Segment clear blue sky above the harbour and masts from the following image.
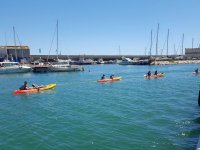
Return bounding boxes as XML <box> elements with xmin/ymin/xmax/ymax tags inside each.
<box><xmin>0</xmin><ymin>0</ymin><xmax>200</xmax><ymax>55</ymax></box>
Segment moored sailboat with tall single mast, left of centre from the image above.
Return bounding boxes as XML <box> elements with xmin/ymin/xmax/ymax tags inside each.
<box><xmin>49</xmin><ymin>20</ymin><xmax>84</xmax><ymax>72</ymax></box>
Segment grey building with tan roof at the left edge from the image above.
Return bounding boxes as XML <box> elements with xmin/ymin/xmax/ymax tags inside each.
<box><xmin>0</xmin><ymin>46</ymin><xmax>30</xmax><ymax>62</ymax></box>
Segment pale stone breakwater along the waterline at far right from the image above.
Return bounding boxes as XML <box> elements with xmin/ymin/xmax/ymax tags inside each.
<box><xmin>151</xmin><ymin>60</ymin><xmax>200</xmax><ymax>65</ymax></box>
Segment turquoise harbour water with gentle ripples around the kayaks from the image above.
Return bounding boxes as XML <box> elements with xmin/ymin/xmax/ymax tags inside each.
<box><xmin>0</xmin><ymin>64</ymin><xmax>200</xmax><ymax>150</ymax></box>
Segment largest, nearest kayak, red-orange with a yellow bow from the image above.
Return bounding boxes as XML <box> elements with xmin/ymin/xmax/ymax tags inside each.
<box><xmin>13</xmin><ymin>84</ymin><xmax>56</xmax><ymax>94</ymax></box>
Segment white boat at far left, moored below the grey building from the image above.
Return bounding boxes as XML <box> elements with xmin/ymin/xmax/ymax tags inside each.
<box><xmin>0</xmin><ymin>61</ymin><xmax>31</xmax><ymax>74</ymax></box>
